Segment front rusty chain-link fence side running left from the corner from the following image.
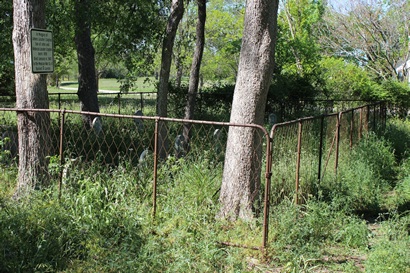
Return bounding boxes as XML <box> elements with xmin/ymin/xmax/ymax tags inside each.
<box><xmin>0</xmin><ymin>108</ymin><xmax>270</xmax><ymax>248</ymax></box>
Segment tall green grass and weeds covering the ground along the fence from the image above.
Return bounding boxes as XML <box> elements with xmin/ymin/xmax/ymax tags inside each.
<box><xmin>0</xmin><ymin>116</ymin><xmax>410</xmax><ymax>272</ymax></box>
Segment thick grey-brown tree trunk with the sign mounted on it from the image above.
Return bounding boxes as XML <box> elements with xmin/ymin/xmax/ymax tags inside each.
<box><xmin>13</xmin><ymin>0</ymin><xmax>50</xmax><ymax>198</ymax></box>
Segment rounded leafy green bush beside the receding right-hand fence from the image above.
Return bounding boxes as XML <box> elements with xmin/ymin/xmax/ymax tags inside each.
<box><xmin>321</xmin><ymin>134</ymin><xmax>396</xmax><ymax>210</ymax></box>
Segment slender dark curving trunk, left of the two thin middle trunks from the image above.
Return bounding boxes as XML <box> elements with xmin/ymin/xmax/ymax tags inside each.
<box><xmin>157</xmin><ymin>0</ymin><xmax>184</xmax><ymax>159</ymax></box>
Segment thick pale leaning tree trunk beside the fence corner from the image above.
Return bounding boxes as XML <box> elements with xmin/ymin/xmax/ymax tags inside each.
<box><xmin>219</xmin><ymin>0</ymin><xmax>279</xmax><ymax>220</ymax></box>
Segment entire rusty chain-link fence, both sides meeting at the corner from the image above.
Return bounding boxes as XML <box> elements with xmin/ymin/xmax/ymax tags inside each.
<box><xmin>0</xmin><ymin>103</ymin><xmax>386</xmax><ymax>252</ymax></box>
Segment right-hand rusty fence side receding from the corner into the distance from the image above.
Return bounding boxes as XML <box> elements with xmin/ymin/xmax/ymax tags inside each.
<box><xmin>270</xmin><ymin>102</ymin><xmax>386</xmax><ymax>204</ymax></box>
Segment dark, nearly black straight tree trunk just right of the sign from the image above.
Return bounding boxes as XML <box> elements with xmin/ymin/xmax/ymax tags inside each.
<box><xmin>74</xmin><ymin>0</ymin><xmax>100</xmax><ymax>128</ymax></box>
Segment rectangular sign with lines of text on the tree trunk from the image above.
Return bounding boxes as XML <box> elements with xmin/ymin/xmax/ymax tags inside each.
<box><xmin>31</xmin><ymin>28</ymin><xmax>54</xmax><ymax>74</ymax></box>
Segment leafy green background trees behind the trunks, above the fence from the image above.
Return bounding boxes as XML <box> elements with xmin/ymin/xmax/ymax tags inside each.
<box><xmin>0</xmin><ymin>0</ymin><xmax>409</xmax><ymax>100</ymax></box>
